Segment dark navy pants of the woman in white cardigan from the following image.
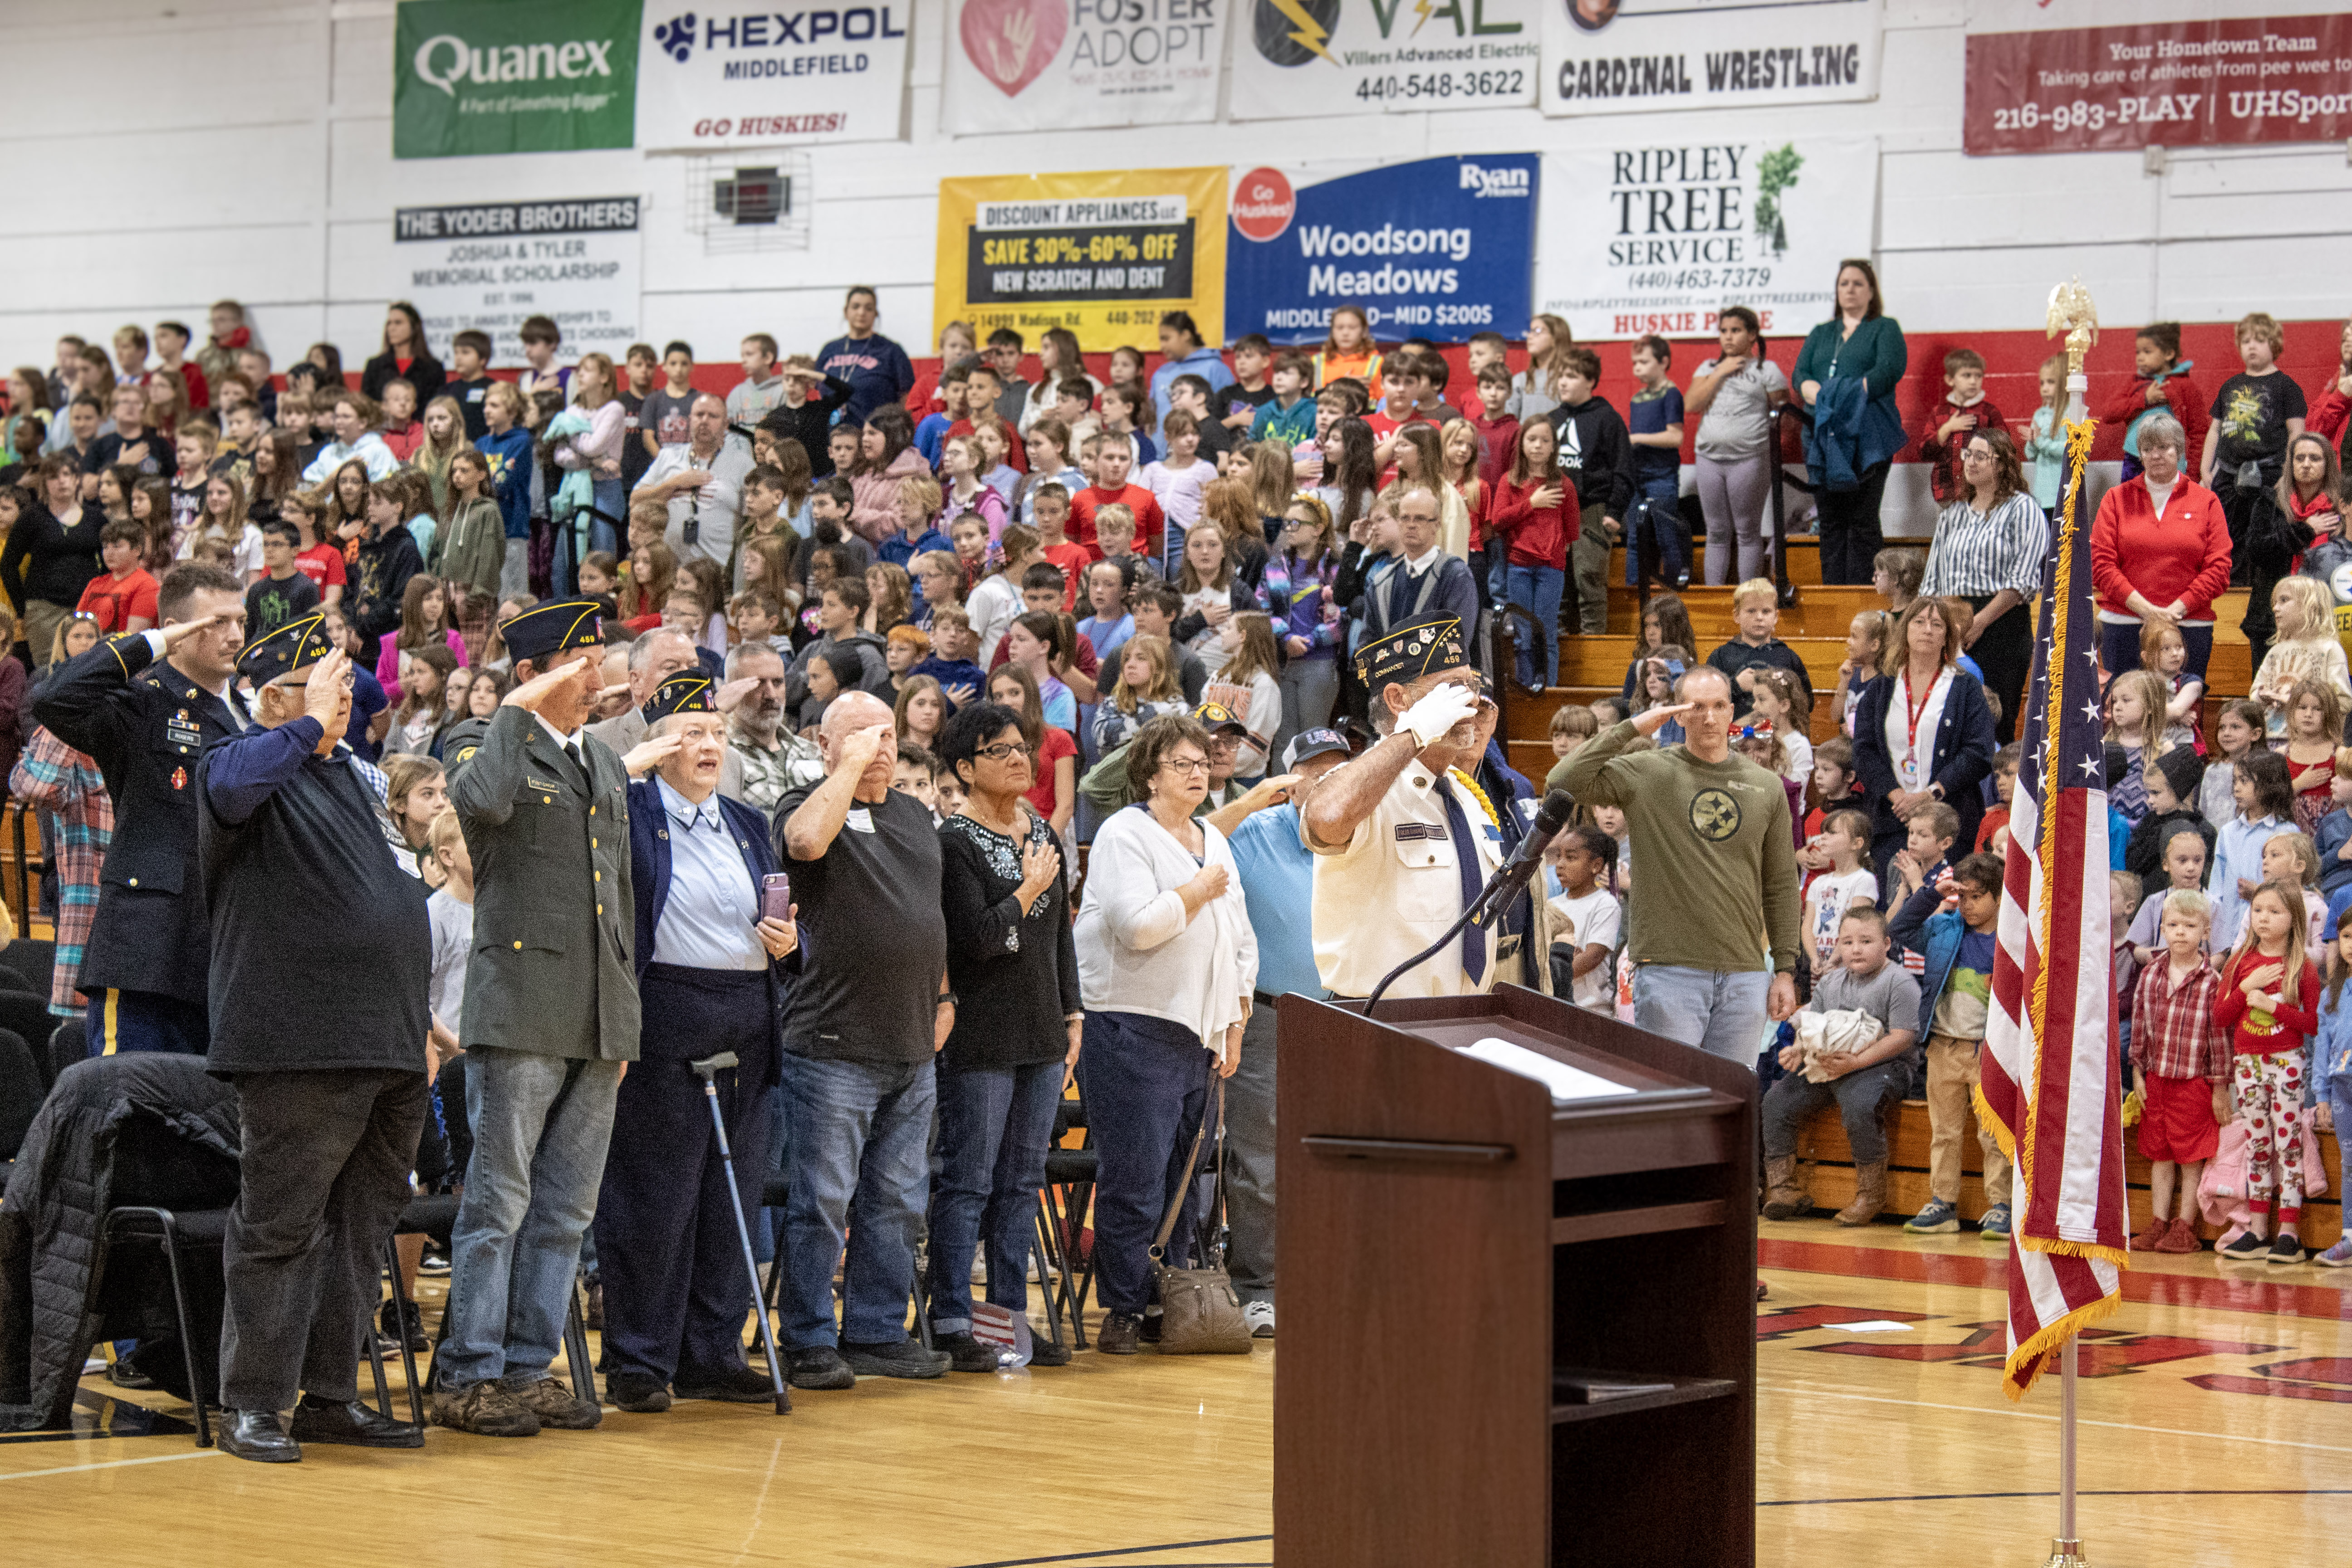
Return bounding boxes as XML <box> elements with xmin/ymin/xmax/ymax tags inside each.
<box><xmin>1077</xmin><ymin>1013</ymin><xmax>1216</xmax><ymax>1316</ymax></box>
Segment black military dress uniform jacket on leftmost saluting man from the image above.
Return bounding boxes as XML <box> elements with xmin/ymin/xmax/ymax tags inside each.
<box><xmin>33</xmin><ymin>632</ymin><xmax>252</xmax><ymax>1006</ymax></box>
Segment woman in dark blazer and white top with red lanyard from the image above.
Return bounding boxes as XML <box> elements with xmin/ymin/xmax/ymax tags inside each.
<box><xmin>1853</xmin><ymin>595</ymin><xmax>1994</xmax><ymax>886</ymax></box>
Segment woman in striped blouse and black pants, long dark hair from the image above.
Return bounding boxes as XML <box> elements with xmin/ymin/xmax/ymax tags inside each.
<box><xmin>1919</xmin><ymin>430</ymin><xmax>2048</xmax><ymax>745</ymax></box>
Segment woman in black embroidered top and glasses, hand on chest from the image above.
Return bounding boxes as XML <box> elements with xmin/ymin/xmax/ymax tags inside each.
<box><xmin>931</xmin><ymin>703</ymin><xmax>1084</xmax><ymax>1373</ymax></box>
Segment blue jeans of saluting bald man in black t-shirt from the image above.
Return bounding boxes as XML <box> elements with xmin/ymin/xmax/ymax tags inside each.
<box><xmin>781</xmin><ymin>1055</ymin><xmax>938</xmax><ymax>1349</ymax></box>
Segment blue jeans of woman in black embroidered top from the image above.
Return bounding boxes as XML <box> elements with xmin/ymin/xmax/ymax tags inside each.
<box><xmin>931</xmin><ymin>1060</ymin><xmax>1063</xmax><ymax>1333</ymax></box>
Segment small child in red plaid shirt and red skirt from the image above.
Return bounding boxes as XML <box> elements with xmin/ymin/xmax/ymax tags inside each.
<box><xmin>2131</xmin><ymin>889</ymin><xmax>2230</xmax><ymax>1253</ymax></box>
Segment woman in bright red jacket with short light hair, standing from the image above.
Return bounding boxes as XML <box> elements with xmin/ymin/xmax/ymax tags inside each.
<box><xmin>2091</xmin><ymin>414</ymin><xmax>2230</xmax><ymax>679</ymax></box>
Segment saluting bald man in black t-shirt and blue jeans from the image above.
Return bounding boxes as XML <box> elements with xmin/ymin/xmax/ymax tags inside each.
<box><xmin>776</xmin><ymin>691</ymin><xmax>955</xmax><ymax>1389</ymax></box>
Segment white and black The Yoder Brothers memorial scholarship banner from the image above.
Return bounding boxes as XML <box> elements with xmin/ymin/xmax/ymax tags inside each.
<box><xmin>393</xmin><ymin>195</ymin><xmax>644</xmax><ymax>364</ymax></box>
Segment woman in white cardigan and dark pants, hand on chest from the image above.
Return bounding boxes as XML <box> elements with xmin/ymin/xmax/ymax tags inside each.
<box><xmin>1075</xmin><ymin>715</ymin><xmax>1258</xmax><ymax>1357</ymax></box>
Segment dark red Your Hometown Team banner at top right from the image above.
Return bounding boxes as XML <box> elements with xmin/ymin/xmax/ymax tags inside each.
<box><xmin>1961</xmin><ymin>14</ymin><xmax>2352</xmax><ymax>155</ymax></box>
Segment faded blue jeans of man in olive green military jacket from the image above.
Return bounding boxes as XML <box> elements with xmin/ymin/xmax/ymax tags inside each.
<box><xmin>437</xmin><ymin>1046</ymin><xmax>621</xmax><ymax>1387</ymax></box>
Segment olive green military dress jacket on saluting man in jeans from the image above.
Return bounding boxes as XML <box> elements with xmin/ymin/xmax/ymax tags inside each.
<box><xmin>449</xmin><ymin>705</ymin><xmax>637</xmax><ymax>1063</ymax></box>
